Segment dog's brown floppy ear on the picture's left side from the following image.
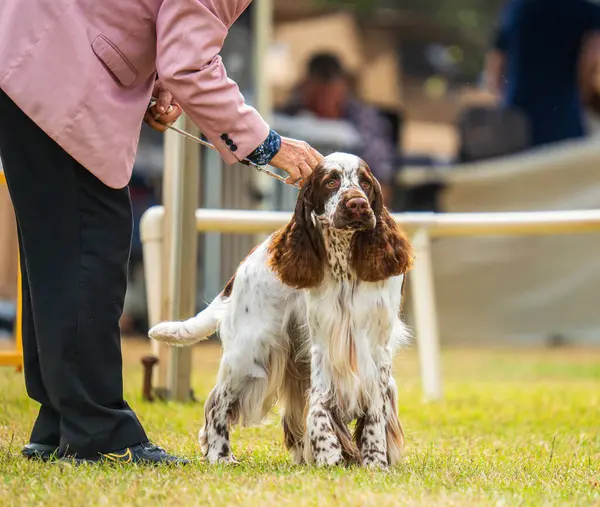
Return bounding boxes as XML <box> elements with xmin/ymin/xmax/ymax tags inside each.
<box><xmin>269</xmin><ymin>181</ymin><xmax>327</xmax><ymax>289</ymax></box>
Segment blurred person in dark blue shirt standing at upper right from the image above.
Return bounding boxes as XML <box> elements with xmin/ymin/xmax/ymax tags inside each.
<box><xmin>485</xmin><ymin>0</ymin><xmax>600</xmax><ymax>146</ymax></box>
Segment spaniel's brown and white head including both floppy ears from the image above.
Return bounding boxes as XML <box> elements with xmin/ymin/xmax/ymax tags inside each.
<box><xmin>269</xmin><ymin>153</ymin><xmax>412</xmax><ymax>288</ymax></box>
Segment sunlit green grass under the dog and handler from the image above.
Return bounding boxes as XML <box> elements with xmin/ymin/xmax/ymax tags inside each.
<box><xmin>0</xmin><ymin>342</ymin><xmax>600</xmax><ymax>507</ymax></box>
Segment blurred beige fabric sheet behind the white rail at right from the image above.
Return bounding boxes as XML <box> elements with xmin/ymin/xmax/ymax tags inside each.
<box><xmin>404</xmin><ymin>142</ymin><xmax>600</xmax><ymax>344</ymax></box>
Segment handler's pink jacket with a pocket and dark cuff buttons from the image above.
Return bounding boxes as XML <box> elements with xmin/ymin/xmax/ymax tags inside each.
<box><xmin>0</xmin><ymin>0</ymin><xmax>269</xmax><ymax>188</ymax></box>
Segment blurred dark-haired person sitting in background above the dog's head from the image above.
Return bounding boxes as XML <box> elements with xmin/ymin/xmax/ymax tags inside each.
<box><xmin>281</xmin><ymin>53</ymin><xmax>395</xmax><ymax>206</ymax></box>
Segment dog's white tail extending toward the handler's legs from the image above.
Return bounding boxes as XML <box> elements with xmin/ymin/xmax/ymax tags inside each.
<box><xmin>148</xmin><ymin>294</ymin><xmax>229</xmax><ymax>347</ymax></box>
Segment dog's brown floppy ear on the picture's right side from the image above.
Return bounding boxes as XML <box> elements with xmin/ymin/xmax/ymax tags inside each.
<box><xmin>352</xmin><ymin>179</ymin><xmax>413</xmax><ymax>282</ymax></box>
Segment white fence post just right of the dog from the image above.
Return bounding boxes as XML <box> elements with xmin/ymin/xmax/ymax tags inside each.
<box><xmin>409</xmin><ymin>228</ymin><xmax>442</xmax><ymax>400</ymax></box>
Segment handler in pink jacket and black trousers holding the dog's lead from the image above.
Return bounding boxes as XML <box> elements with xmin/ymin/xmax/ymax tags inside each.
<box><xmin>0</xmin><ymin>0</ymin><xmax>321</xmax><ymax>463</ymax></box>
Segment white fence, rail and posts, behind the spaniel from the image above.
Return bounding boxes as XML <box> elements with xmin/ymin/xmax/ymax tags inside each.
<box><xmin>141</xmin><ymin>206</ymin><xmax>600</xmax><ymax>399</ymax></box>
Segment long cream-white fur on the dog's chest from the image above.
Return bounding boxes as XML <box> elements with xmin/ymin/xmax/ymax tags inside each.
<box><xmin>306</xmin><ymin>272</ymin><xmax>406</xmax><ymax>419</ymax></box>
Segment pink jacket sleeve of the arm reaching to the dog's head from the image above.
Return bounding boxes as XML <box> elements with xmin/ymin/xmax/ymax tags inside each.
<box><xmin>156</xmin><ymin>0</ymin><xmax>269</xmax><ymax>164</ymax></box>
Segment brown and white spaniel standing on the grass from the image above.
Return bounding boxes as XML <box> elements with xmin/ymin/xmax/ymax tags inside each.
<box><xmin>149</xmin><ymin>153</ymin><xmax>412</xmax><ymax>467</ymax></box>
